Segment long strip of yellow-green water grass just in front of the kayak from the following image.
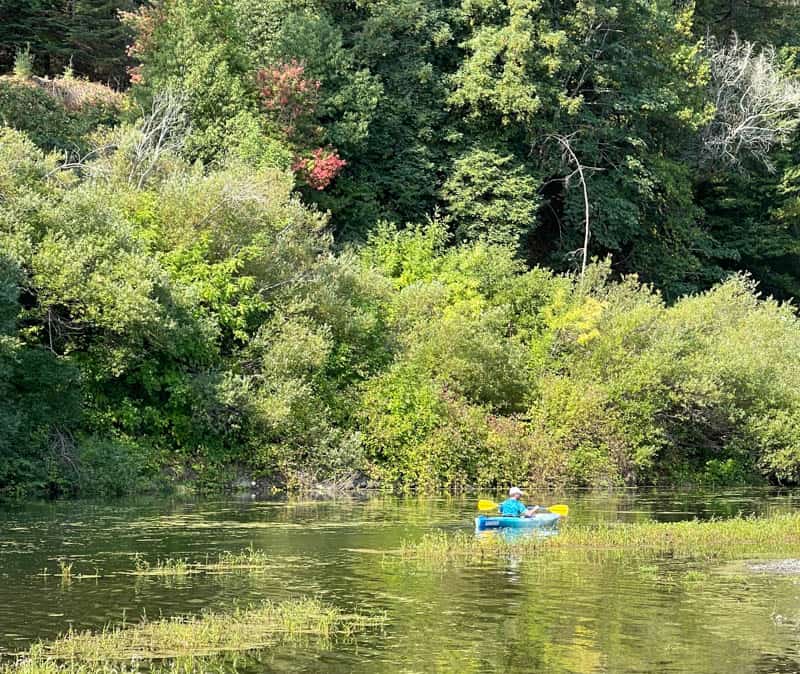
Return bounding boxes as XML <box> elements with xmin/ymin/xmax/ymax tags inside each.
<box><xmin>396</xmin><ymin>513</ymin><xmax>800</xmax><ymax>564</ymax></box>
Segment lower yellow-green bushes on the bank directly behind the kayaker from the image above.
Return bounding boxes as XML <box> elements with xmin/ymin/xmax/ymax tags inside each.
<box><xmin>360</xmin><ymin>227</ymin><xmax>800</xmax><ymax>487</ymax></box>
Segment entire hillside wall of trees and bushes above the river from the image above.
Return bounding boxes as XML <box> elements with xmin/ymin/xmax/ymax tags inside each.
<box><xmin>0</xmin><ymin>0</ymin><xmax>800</xmax><ymax>494</ymax></box>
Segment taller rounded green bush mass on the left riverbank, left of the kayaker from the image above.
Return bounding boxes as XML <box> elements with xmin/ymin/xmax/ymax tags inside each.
<box><xmin>0</xmin><ymin>119</ymin><xmax>390</xmax><ymax>493</ymax></box>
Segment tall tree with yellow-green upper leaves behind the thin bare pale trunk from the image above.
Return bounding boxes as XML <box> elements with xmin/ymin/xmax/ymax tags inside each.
<box><xmin>450</xmin><ymin>0</ymin><xmax>708</xmax><ymax>294</ymax></box>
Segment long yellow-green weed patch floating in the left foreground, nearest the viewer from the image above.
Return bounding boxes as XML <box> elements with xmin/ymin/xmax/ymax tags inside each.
<box><xmin>22</xmin><ymin>599</ymin><xmax>385</xmax><ymax>660</ymax></box>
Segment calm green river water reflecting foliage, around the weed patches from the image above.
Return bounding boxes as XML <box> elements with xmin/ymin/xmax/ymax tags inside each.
<box><xmin>0</xmin><ymin>491</ymin><xmax>800</xmax><ymax>674</ymax></box>
